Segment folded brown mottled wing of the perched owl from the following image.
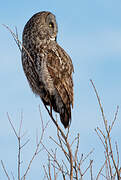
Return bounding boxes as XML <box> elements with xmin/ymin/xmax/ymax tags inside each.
<box><xmin>47</xmin><ymin>44</ymin><xmax>74</xmax><ymax>109</ymax></box>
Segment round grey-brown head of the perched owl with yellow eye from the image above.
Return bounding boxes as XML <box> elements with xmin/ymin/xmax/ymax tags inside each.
<box><xmin>24</xmin><ymin>11</ymin><xmax>58</xmax><ymax>41</ymax></box>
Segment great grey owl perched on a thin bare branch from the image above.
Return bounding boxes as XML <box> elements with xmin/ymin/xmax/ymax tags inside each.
<box><xmin>22</xmin><ymin>11</ymin><xmax>74</xmax><ymax>128</ymax></box>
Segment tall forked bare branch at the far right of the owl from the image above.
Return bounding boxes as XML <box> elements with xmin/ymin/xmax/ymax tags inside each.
<box><xmin>90</xmin><ymin>80</ymin><xmax>120</xmax><ymax>180</ymax></box>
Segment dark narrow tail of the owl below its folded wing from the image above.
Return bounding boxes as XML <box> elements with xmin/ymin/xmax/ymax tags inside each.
<box><xmin>60</xmin><ymin>108</ymin><xmax>71</xmax><ymax>128</ymax></box>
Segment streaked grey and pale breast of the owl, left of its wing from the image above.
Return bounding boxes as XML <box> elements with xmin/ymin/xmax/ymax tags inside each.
<box><xmin>22</xmin><ymin>46</ymin><xmax>55</xmax><ymax>100</ymax></box>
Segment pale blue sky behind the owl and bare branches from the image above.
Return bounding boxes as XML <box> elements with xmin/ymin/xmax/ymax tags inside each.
<box><xmin>0</xmin><ymin>0</ymin><xmax>121</xmax><ymax>179</ymax></box>
